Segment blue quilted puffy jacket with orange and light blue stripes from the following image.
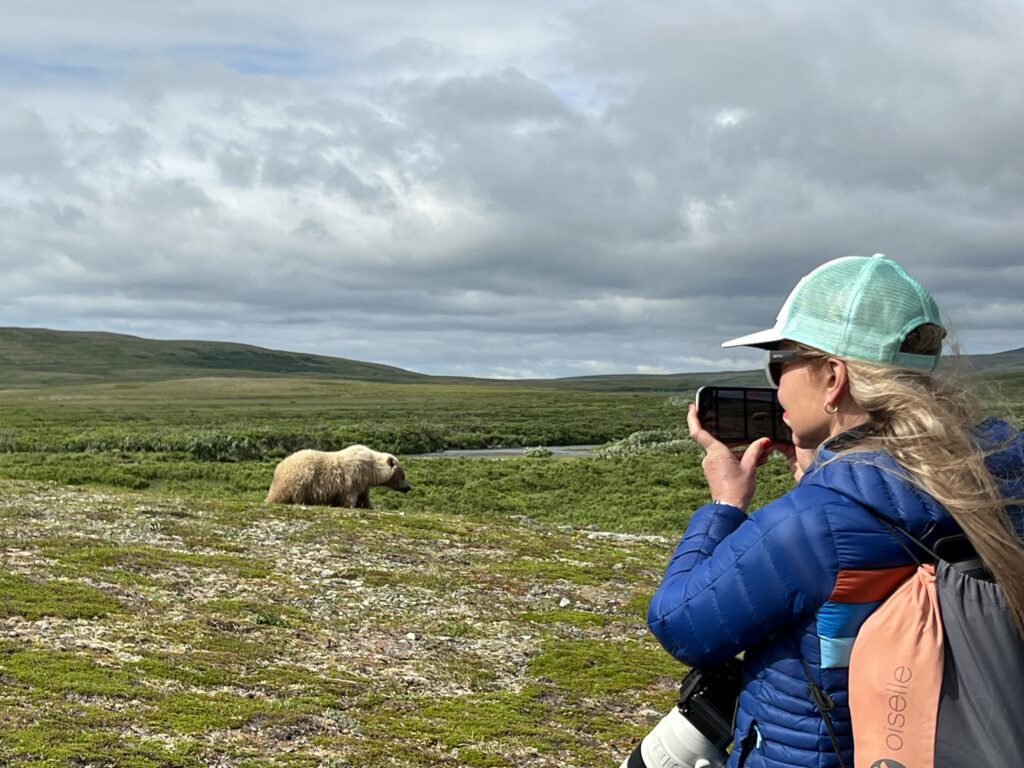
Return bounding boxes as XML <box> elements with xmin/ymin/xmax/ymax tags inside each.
<box><xmin>647</xmin><ymin>421</ymin><xmax>1024</xmax><ymax>768</ymax></box>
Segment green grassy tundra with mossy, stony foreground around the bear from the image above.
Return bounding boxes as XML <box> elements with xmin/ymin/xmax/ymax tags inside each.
<box><xmin>0</xmin><ymin>331</ymin><xmax>1019</xmax><ymax>768</ymax></box>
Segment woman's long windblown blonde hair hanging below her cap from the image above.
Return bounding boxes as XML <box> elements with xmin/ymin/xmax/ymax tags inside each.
<box><xmin>808</xmin><ymin>326</ymin><xmax>1024</xmax><ymax>637</ymax></box>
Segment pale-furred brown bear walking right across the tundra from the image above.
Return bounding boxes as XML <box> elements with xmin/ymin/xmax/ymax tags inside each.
<box><xmin>266</xmin><ymin>445</ymin><xmax>413</xmax><ymax>509</ymax></box>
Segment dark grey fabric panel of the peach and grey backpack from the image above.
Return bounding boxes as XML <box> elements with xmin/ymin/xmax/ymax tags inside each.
<box><xmin>935</xmin><ymin>560</ymin><xmax>1024</xmax><ymax>768</ymax></box>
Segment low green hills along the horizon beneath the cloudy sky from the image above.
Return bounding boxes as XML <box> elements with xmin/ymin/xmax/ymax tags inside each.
<box><xmin>0</xmin><ymin>328</ymin><xmax>1024</xmax><ymax>392</ymax></box>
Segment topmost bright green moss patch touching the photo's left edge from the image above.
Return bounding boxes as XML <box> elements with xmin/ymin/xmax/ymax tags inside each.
<box><xmin>0</xmin><ymin>573</ymin><xmax>124</xmax><ymax>622</ymax></box>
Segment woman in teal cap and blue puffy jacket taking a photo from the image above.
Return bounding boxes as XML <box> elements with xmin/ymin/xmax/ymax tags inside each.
<box><xmin>647</xmin><ymin>255</ymin><xmax>1024</xmax><ymax>768</ymax></box>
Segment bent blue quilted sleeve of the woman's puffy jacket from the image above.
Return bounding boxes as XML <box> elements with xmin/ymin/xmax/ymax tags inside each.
<box><xmin>647</xmin><ymin>488</ymin><xmax>839</xmax><ymax>667</ymax></box>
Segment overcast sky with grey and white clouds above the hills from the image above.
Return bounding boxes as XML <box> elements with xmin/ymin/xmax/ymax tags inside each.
<box><xmin>0</xmin><ymin>0</ymin><xmax>1024</xmax><ymax>377</ymax></box>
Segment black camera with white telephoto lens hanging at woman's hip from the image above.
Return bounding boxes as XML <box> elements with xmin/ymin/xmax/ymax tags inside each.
<box><xmin>620</xmin><ymin>658</ymin><xmax>742</xmax><ymax>768</ymax></box>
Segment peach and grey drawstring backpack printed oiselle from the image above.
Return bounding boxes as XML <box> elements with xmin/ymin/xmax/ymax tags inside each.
<box><xmin>849</xmin><ymin>522</ymin><xmax>1024</xmax><ymax>768</ymax></box>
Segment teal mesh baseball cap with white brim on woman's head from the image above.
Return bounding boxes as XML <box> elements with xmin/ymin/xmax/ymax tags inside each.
<box><xmin>722</xmin><ymin>253</ymin><xmax>945</xmax><ymax>371</ymax></box>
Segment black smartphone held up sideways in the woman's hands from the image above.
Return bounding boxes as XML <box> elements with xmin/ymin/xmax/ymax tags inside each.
<box><xmin>697</xmin><ymin>387</ymin><xmax>793</xmax><ymax>442</ymax></box>
